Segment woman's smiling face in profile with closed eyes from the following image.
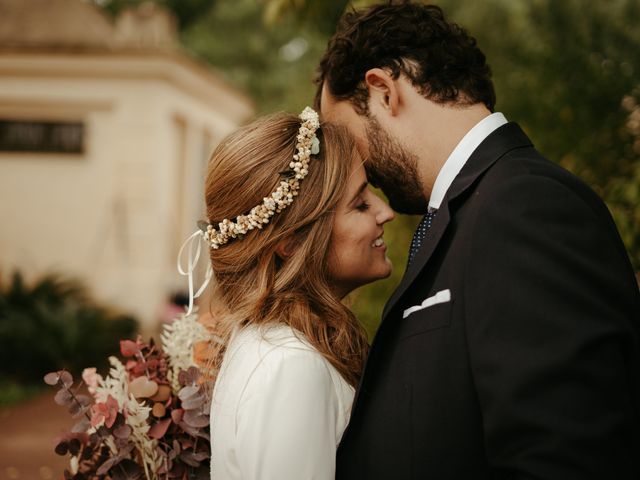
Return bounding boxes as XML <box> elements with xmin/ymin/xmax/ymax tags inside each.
<box><xmin>329</xmin><ymin>159</ymin><xmax>394</xmax><ymax>296</ymax></box>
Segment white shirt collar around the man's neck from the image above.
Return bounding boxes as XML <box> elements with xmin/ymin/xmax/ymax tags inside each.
<box><xmin>429</xmin><ymin>112</ymin><xmax>507</xmax><ymax>212</ymax></box>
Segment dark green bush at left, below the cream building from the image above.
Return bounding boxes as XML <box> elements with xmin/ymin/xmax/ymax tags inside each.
<box><xmin>0</xmin><ymin>272</ymin><xmax>136</xmax><ymax>382</ymax></box>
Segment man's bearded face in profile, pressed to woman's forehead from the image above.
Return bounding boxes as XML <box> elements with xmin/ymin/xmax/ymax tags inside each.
<box><xmin>320</xmin><ymin>88</ymin><xmax>427</xmax><ymax>214</ymax></box>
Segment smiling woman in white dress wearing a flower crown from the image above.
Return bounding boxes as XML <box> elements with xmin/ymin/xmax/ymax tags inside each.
<box><xmin>190</xmin><ymin>108</ymin><xmax>393</xmax><ymax>480</ymax></box>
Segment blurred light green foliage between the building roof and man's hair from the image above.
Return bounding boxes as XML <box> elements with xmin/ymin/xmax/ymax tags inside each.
<box><xmin>181</xmin><ymin>0</ymin><xmax>326</xmax><ymax>113</ymax></box>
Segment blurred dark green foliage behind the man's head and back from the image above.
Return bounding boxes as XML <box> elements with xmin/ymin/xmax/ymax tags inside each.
<box><xmin>443</xmin><ymin>0</ymin><xmax>640</xmax><ymax>271</ymax></box>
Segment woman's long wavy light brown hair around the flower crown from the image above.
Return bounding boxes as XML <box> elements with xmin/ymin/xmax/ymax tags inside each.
<box><xmin>200</xmin><ymin>114</ymin><xmax>368</xmax><ymax>386</ymax></box>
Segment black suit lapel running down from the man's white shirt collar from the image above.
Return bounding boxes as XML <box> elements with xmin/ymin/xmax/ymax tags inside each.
<box><xmin>382</xmin><ymin>123</ymin><xmax>532</xmax><ymax>321</ymax></box>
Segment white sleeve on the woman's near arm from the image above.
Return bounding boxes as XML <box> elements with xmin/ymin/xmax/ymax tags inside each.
<box><xmin>236</xmin><ymin>348</ymin><xmax>338</xmax><ymax>480</ymax></box>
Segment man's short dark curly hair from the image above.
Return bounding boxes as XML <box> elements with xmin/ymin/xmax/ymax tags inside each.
<box><xmin>316</xmin><ymin>1</ymin><xmax>496</xmax><ymax>115</ymax></box>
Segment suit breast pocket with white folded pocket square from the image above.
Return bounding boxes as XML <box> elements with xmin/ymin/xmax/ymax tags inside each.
<box><xmin>400</xmin><ymin>290</ymin><xmax>454</xmax><ymax>339</ymax></box>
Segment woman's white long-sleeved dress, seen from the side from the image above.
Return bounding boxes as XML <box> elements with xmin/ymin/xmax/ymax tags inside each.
<box><xmin>211</xmin><ymin>325</ymin><xmax>354</xmax><ymax>480</ymax></box>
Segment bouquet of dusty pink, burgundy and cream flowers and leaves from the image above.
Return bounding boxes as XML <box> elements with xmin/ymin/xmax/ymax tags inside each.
<box><xmin>44</xmin><ymin>313</ymin><xmax>211</xmax><ymax>480</ymax></box>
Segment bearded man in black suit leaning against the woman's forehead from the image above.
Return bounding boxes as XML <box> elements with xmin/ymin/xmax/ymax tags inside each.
<box><xmin>317</xmin><ymin>3</ymin><xmax>640</xmax><ymax>480</ymax></box>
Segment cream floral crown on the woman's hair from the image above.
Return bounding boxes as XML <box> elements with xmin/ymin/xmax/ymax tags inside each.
<box><xmin>198</xmin><ymin>107</ymin><xmax>320</xmax><ymax>249</ymax></box>
